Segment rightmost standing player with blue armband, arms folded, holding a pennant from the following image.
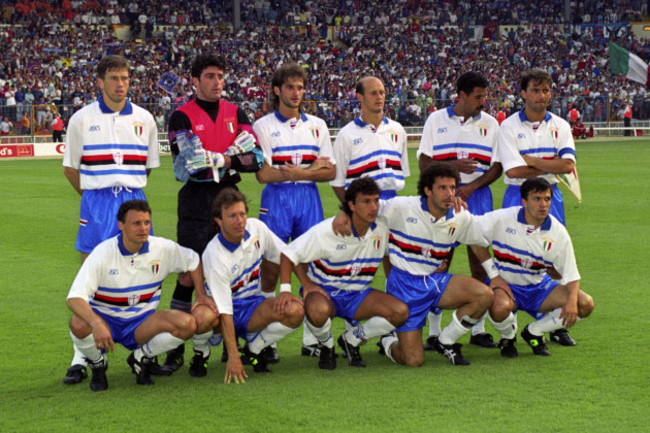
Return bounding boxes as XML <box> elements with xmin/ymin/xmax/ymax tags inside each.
<box><xmin>498</xmin><ymin>70</ymin><xmax>576</xmax><ymax>346</ymax></box>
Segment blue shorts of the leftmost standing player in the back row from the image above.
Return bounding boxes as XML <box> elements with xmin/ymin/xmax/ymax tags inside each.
<box><xmin>75</xmin><ymin>186</ymin><xmax>147</xmax><ymax>253</ymax></box>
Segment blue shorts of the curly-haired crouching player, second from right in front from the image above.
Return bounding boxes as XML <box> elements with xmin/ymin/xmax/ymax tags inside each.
<box><xmin>386</xmin><ymin>266</ymin><xmax>453</xmax><ymax>332</ymax></box>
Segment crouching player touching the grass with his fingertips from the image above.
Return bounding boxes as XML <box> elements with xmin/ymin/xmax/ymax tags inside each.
<box><xmin>190</xmin><ymin>188</ymin><xmax>304</xmax><ymax>383</ymax></box>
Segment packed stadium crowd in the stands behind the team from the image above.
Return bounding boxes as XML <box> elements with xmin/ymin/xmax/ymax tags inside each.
<box><xmin>0</xmin><ymin>0</ymin><xmax>650</xmax><ymax>133</ymax></box>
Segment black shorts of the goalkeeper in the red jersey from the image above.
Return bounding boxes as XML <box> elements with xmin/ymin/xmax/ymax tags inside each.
<box><xmin>176</xmin><ymin>180</ymin><xmax>237</xmax><ymax>255</ymax></box>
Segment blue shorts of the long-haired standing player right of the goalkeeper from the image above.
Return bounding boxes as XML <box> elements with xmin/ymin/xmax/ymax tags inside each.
<box><xmin>260</xmin><ymin>183</ymin><xmax>323</xmax><ymax>243</ymax></box>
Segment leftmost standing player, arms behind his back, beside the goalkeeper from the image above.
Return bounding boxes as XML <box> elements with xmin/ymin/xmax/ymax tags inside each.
<box><xmin>63</xmin><ymin>55</ymin><xmax>160</xmax><ymax>385</ymax></box>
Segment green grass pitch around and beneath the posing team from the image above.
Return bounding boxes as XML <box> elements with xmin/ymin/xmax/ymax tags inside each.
<box><xmin>0</xmin><ymin>140</ymin><xmax>650</xmax><ymax>432</ymax></box>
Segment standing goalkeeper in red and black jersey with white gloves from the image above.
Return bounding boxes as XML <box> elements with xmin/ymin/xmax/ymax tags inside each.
<box><xmin>162</xmin><ymin>55</ymin><xmax>264</xmax><ymax>373</ymax></box>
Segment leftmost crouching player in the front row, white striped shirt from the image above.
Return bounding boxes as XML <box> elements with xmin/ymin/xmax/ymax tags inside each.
<box><xmin>67</xmin><ymin>200</ymin><xmax>203</xmax><ymax>391</ymax></box>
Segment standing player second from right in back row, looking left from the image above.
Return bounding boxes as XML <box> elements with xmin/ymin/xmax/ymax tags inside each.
<box><xmin>417</xmin><ymin>72</ymin><xmax>502</xmax><ymax>350</ymax></box>
